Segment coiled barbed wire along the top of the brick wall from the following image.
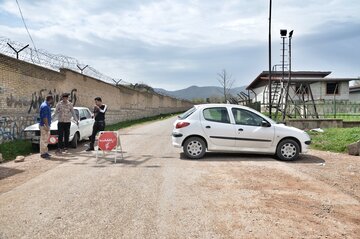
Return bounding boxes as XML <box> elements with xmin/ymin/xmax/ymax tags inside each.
<box><xmin>0</xmin><ymin>36</ymin><xmax>131</xmax><ymax>85</ymax></box>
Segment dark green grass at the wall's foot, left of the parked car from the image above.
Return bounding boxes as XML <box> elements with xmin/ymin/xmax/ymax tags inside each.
<box><xmin>0</xmin><ymin>139</ymin><xmax>33</xmax><ymax>161</ymax></box>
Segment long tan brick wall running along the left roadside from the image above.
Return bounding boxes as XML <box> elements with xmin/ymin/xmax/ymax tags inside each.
<box><xmin>0</xmin><ymin>54</ymin><xmax>192</xmax><ymax>143</ymax></box>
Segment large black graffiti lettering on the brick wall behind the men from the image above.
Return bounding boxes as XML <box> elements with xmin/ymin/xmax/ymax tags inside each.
<box><xmin>6</xmin><ymin>89</ymin><xmax>78</xmax><ymax>114</ymax></box>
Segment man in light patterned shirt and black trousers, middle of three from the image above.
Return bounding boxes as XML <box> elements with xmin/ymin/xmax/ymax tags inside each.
<box><xmin>54</xmin><ymin>93</ymin><xmax>79</xmax><ymax>154</ymax></box>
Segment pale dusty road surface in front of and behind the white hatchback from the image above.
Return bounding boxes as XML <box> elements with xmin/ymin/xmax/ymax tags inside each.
<box><xmin>0</xmin><ymin>118</ymin><xmax>360</xmax><ymax>239</ymax></box>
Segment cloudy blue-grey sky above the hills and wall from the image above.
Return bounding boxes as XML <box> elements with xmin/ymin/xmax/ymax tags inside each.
<box><xmin>0</xmin><ymin>0</ymin><xmax>360</xmax><ymax>90</ymax></box>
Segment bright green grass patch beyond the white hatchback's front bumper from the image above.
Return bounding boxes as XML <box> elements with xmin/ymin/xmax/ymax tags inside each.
<box><xmin>308</xmin><ymin>127</ymin><xmax>360</xmax><ymax>153</ymax></box>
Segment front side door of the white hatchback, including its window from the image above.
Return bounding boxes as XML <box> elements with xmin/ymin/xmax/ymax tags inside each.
<box><xmin>231</xmin><ymin>108</ymin><xmax>275</xmax><ymax>152</ymax></box>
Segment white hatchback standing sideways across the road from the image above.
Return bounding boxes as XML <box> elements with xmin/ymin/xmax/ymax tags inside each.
<box><xmin>172</xmin><ymin>104</ymin><xmax>311</xmax><ymax>161</ymax></box>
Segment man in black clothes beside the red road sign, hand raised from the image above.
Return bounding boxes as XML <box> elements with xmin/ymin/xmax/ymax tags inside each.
<box><xmin>86</xmin><ymin>97</ymin><xmax>107</xmax><ymax>151</ymax></box>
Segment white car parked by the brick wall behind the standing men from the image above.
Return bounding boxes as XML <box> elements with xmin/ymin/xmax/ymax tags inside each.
<box><xmin>24</xmin><ymin>107</ymin><xmax>94</xmax><ymax>148</ymax></box>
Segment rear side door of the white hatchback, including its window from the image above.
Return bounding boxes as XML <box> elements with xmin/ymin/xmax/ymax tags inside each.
<box><xmin>201</xmin><ymin>107</ymin><xmax>236</xmax><ymax>150</ymax></box>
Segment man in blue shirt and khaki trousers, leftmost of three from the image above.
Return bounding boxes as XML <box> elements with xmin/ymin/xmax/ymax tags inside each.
<box><xmin>39</xmin><ymin>95</ymin><xmax>54</xmax><ymax>159</ymax></box>
